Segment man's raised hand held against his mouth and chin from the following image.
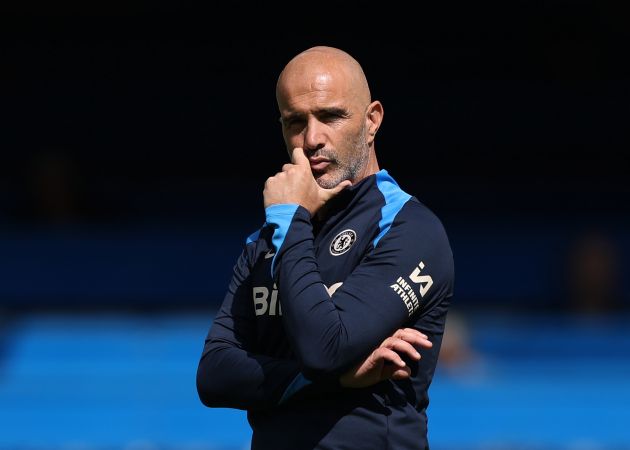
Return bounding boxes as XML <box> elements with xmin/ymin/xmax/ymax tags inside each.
<box><xmin>263</xmin><ymin>147</ymin><xmax>352</xmax><ymax>216</ymax></box>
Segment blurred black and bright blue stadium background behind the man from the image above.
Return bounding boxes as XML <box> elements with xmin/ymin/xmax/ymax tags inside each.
<box><xmin>0</xmin><ymin>1</ymin><xmax>630</xmax><ymax>450</ymax></box>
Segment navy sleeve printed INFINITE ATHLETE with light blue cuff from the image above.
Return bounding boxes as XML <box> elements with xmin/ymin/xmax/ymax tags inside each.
<box><xmin>266</xmin><ymin>202</ymin><xmax>454</xmax><ymax>379</ymax></box>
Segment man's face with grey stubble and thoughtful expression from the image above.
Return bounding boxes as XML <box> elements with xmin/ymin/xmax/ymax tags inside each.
<box><xmin>278</xmin><ymin>72</ymin><xmax>369</xmax><ymax>189</ymax></box>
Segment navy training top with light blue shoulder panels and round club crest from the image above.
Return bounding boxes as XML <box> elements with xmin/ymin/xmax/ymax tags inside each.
<box><xmin>197</xmin><ymin>170</ymin><xmax>454</xmax><ymax>450</ymax></box>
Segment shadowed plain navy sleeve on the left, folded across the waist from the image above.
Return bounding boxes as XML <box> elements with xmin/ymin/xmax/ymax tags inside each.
<box><xmin>197</xmin><ymin>246</ymin><xmax>299</xmax><ymax>410</ymax></box>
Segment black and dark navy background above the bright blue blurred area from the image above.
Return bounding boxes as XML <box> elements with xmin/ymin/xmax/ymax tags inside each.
<box><xmin>0</xmin><ymin>1</ymin><xmax>630</xmax><ymax>308</ymax></box>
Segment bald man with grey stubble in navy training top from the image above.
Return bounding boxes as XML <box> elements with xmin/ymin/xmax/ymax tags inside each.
<box><xmin>197</xmin><ymin>47</ymin><xmax>454</xmax><ymax>450</ymax></box>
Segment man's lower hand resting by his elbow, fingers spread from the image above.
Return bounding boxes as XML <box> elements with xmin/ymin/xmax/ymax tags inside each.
<box><xmin>339</xmin><ymin>328</ymin><xmax>433</xmax><ymax>388</ymax></box>
